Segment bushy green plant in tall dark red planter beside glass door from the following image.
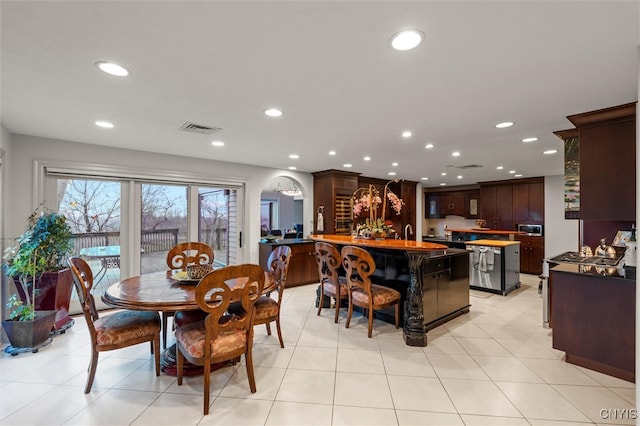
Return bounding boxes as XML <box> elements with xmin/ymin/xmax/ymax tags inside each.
<box><xmin>3</xmin><ymin>209</ymin><xmax>73</xmax><ymax>331</ymax></box>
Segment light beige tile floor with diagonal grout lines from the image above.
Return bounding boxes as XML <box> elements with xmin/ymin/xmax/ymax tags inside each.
<box><xmin>0</xmin><ymin>275</ymin><xmax>635</xmax><ymax>426</ymax></box>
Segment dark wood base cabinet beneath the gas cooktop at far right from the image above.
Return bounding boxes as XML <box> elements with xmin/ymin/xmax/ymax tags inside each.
<box><xmin>550</xmin><ymin>264</ymin><xmax>636</xmax><ymax>382</ymax></box>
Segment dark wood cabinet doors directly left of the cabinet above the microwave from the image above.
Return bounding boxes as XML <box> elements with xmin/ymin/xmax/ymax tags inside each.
<box><xmin>480</xmin><ymin>181</ymin><xmax>515</xmax><ymax>230</ymax></box>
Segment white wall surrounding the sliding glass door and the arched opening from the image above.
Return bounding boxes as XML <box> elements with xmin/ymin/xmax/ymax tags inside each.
<box><xmin>2</xmin><ymin>134</ymin><xmax>313</xmax><ymax>263</ymax></box>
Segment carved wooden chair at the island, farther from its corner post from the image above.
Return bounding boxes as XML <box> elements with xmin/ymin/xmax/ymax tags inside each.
<box><xmin>315</xmin><ymin>241</ymin><xmax>349</xmax><ymax>324</ymax></box>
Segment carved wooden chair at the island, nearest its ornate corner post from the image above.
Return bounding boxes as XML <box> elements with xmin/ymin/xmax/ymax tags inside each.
<box><xmin>341</xmin><ymin>246</ymin><xmax>400</xmax><ymax>337</ymax></box>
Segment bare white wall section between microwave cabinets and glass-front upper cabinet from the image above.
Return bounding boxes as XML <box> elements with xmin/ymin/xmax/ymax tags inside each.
<box><xmin>544</xmin><ymin>175</ymin><xmax>579</xmax><ymax>257</ymax></box>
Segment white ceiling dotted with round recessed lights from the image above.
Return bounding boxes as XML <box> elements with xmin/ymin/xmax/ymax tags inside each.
<box><xmin>0</xmin><ymin>0</ymin><xmax>640</xmax><ymax>185</ymax></box>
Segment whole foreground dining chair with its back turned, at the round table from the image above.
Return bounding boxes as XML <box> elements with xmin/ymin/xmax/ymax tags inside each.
<box><xmin>176</xmin><ymin>264</ymin><xmax>265</xmax><ymax>414</ymax></box>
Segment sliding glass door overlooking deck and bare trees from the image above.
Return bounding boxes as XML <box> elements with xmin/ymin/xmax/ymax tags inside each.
<box><xmin>45</xmin><ymin>171</ymin><xmax>241</xmax><ymax>312</ymax></box>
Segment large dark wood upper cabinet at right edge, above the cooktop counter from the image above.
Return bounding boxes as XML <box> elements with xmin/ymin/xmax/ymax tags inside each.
<box><xmin>556</xmin><ymin>102</ymin><xmax>636</xmax><ymax>221</ymax></box>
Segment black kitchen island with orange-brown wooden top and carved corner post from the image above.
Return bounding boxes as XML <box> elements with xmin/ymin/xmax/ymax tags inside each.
<box><xmin>311</xmin><ymin>235</ymin><xmax>470</xmax><ymax>346</ymax></box>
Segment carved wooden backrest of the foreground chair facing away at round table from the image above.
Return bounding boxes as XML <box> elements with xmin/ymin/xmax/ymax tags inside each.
<box><xmin>196</xmin><ymin>264</ymin><xmax>264</xmax><ymax>358</ymax></box>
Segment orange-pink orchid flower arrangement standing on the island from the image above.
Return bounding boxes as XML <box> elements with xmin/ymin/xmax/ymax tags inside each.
<box><xmin>353</xmin><ymin>182</ymin><xmax>404</xmax><ymax>238</ymax></box>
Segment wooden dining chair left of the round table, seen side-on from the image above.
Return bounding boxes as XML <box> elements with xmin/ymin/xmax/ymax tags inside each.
<box><xmin>67</xmin><ymin>257</ymin><xmax>160</xmax><ymax>393</ymax></box>
